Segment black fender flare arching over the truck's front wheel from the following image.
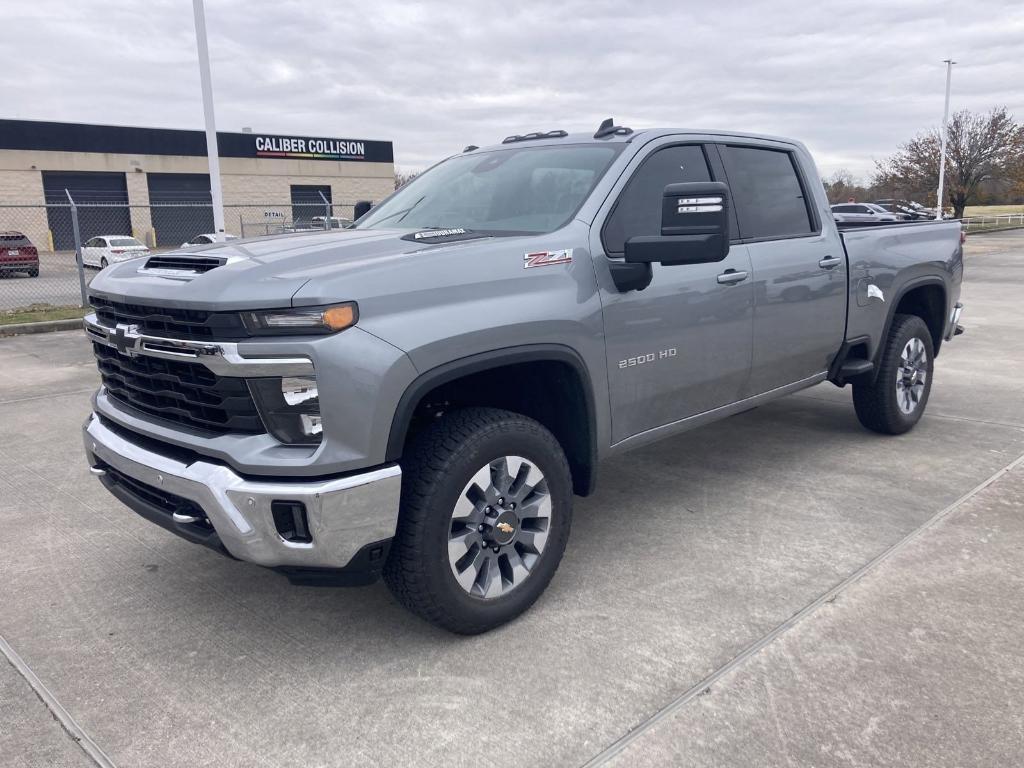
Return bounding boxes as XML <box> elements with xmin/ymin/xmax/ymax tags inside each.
<box><xmin>385</xmin><ymin>344</ymin><xmax>597</xmax><ymax>475</ymax></box>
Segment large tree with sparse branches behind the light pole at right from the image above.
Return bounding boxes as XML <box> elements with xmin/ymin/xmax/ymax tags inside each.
<box><xmin>874</xmin><ymin>106</ymin><xmax>1024</xmax><ymax>218</ymax></box>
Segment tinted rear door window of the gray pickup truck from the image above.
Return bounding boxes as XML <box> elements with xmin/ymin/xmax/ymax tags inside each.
<box><xmin>722</xmin><ymin>146</ymin><xmax>814</xmax><ymax>239</ymax></box>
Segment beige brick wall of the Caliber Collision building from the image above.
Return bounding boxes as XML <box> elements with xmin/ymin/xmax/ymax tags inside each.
<box><xmin>0</xmin><ymin>150</ymin><xmax>394</xmax><ymax>250</ymax></box>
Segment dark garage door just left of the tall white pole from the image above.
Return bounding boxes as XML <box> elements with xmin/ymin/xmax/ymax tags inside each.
<box><xmin>146</xmin><ymin>173</ymin><xmax>213</xmax><ymax>246</ymax></box>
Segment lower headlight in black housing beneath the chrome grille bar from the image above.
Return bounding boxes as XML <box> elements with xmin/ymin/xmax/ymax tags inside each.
<box><xmin>249</xmin><ymin>376</ymin><xmax>324</xmax><ymax>445</ymax></box>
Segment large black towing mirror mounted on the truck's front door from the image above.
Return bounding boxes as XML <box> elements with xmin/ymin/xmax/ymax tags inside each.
<box><xmin>626</xmin><ymin>181</ymin><xmax>729</xmax><ymax>266</ymax></box>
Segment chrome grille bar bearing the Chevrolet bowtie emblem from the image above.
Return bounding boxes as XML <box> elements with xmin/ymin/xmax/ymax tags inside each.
<box><xmin>83</xmin><ymin>314</ymin><xmax>313</xmax><ymax>378</ymax></box>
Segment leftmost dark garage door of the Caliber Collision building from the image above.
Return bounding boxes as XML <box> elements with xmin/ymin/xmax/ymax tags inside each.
<box><xmin>43</xmin><ymin>171</ymin><xmax>131</xmax><ymax>251</ymax></box>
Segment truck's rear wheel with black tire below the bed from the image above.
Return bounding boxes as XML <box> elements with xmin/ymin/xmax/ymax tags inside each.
<box><xmin>853</xmin><ymin>314</ymin><xmax>934</xmax><ymax>434</ymax></box>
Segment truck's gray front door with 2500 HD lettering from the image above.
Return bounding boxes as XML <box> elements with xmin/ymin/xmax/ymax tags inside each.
<box><xmin>597</xmin><ymin>142</ymin><xmax>754</xmax><ymax>442</ymax></box>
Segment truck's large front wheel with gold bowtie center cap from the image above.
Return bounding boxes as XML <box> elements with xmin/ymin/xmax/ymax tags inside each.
<box><xmin>384</xmin><ymin>408</ymin><xmax>572</xmax><ymax>635</ymax></box>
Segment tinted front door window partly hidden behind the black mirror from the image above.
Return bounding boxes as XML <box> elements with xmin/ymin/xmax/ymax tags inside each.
<box><xmin>602</xmin><ymin>144</ymin><xmax>711</xmax><ymax>256</ymax></box>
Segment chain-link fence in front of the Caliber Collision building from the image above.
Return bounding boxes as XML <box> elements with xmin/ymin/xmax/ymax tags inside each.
<box><xmin>0</xmin><ymin>196</ymin><xmax>366</xmax><ymax>322</ymax></box>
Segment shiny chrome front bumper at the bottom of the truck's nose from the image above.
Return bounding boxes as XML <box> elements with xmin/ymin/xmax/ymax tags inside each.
<box><xmin>83</xmin><ymin>415</ymin><xmax>401</xmax><ymax>568</ymax></box>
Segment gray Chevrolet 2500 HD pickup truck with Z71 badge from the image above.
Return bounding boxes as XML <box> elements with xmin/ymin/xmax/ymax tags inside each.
<box><xmin>84</xmin><ymin>121</ymin><xmax>963</xmax><ymax>634</ymax></box>
